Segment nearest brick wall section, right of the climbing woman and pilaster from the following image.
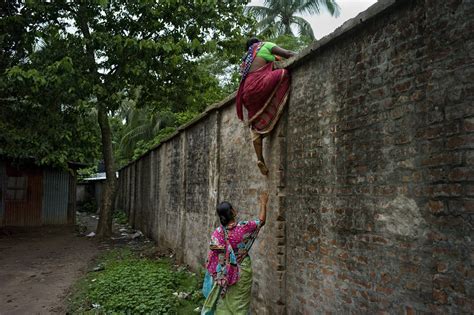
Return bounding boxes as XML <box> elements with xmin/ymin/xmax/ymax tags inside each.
<box><xmin>285</xmin><ymin>1</ymin><xmax>474</xmax><ymax>313</ymax></box>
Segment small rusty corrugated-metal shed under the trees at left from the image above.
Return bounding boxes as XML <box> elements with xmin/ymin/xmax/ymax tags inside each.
<box><xmin>0</xmin><ymin>157</ymin><xmax>80</xmax><ymax>226</ymax></box>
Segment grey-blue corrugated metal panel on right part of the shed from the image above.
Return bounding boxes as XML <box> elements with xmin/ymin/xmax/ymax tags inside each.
<box><xmin>42</xmin><ymin>169</ymin><xmax>70</xmax><ymax>224</ymax></box>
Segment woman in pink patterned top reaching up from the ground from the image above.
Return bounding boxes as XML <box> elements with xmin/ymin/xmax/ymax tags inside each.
<box><xmin>201</xmin><ymin>192</ymin><xmax>268</xmax><ymax>315</ymax></box>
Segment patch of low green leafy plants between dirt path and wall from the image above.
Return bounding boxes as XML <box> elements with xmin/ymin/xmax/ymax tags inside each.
<box><xmin>68</xmin><ymin>248</ymin><xmax>203</xmax><ymax>314</ymax></box>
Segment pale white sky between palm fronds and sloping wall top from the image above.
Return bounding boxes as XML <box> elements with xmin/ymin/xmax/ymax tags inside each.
<box><xmin>250</xmin><ymin>0</ymin><xmax>377</xmax><ymax>39</ymax></box>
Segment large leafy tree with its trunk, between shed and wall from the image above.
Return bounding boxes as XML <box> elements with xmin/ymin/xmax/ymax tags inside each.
<box><xmin>0</xmin><ymin>0</ymin><xmax>249</xmax><ymax>236</ymax></box>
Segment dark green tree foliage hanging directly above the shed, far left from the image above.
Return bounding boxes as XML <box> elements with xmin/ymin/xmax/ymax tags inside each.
<box><xmin>0</xmin><ymin>1</ymin><xmax>99</xmax><ymax>169</ymax></box>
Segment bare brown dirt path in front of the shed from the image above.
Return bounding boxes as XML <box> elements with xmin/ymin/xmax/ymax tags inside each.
<box><xmin>0</xmin><ymin>214</ymin><xmax>100</xmax><ymax>315</ymax></box>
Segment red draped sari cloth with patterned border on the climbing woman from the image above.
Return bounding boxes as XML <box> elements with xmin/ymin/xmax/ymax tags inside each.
<box><xmin>236</xmin><ymin>62</ymin><xmax>290</xmax><ymax>135</ymax></box>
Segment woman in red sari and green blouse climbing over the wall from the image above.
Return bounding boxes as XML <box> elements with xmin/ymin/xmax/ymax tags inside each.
<box><xmin>236</xmin><ymin>38</ymin><xmax>295</xmax><ymax>175</ymax></box>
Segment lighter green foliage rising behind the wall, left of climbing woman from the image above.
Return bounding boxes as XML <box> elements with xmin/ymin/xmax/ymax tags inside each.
<box><xmin>114</xmin><ymin>25</ymin><xmax>253</xmax><ymax>165</ymax></box>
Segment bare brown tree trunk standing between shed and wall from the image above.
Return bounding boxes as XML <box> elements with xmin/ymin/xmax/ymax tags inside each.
<box><xmin>97</xmin><ymin>104</ymin><xmax>118</xmax><ymax>237</ymax></box>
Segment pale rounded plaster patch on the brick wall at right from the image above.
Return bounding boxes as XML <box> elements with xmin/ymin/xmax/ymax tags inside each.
<box><xmin>377</xmin><ymin>195</ymin><xmax>426</xmax><ymax>237</ymax></box>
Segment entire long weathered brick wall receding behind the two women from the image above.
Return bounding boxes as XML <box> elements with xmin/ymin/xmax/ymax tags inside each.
<box><xmin>118</xmin><ymin>0</ymin><xmax>474</xmax><ymax>314</ymax></box>
